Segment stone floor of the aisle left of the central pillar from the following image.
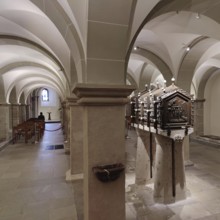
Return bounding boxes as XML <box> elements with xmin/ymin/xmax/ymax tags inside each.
<box><xmin>0</xmin><ymin>124</ymin><xmax>77</xmax><ymax>220</ymax></box>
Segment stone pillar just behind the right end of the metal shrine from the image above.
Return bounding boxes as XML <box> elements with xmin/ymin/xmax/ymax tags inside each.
<box><xmin>193</xmin><ymin>99</ymin><xmax>205</xmax><ymax>136</ymax></box>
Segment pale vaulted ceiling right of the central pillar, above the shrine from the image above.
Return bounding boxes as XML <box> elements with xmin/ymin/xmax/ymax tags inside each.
<box><xmin>128</xmin><ymin>0</ymin><xmax>220</xmax><ymax>97</ymax></box>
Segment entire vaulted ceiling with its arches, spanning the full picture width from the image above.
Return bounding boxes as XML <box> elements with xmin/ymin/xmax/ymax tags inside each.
<box><xmin>0</xmin><ymin>0</ymin><xmax>220</xmax><ymax>103</ymax></box>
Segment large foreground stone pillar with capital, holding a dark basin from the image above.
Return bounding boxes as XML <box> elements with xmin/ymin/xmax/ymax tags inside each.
<box><xmin>73</xmin><ymin>84</ymin><xmax>134</xmax><ymax>220</ymax></box>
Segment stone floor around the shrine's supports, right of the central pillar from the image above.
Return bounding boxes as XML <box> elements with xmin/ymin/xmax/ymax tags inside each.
<box><xmin>126</xmin><ymin>130</ymin><xmax>220</xmax><ymax>220</ymax></box>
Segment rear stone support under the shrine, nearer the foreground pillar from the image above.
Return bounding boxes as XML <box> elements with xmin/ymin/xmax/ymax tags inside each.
<box><xmin>135</xmin><ymin>129</ymin><xmax>156</xmax><ymax>185</ymax></box>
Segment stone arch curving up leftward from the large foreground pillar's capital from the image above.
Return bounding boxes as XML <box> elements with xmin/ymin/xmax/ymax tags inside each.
<box><xmin>30</xmin><ymin>0</ymin><xmax>87</xmax><ymax>82</ymax></box>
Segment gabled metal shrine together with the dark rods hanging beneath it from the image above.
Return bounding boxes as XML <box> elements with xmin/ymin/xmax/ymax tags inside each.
<box><xmin>130</xmin><ymin>79</ymin><xmax>193</xmax><ymax>197</ymax></box>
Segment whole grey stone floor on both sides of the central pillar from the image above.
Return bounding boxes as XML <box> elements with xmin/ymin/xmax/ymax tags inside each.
<box><xmin>0</xmin><ymin>123</ymin><xmax>220</xmax><ymax>220</ymax></box>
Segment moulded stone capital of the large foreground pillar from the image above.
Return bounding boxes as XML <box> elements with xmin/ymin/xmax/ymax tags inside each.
<box><xmin>73</xmin><ymin>83</ymin><xmax>135</xmax><ymax>105</ymax></box>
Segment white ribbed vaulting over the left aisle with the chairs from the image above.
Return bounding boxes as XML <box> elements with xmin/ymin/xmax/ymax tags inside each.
<box><xmin>0</xmin><ymin>0</ymin><xmax>74</xmax><ymax>102</ymax></box>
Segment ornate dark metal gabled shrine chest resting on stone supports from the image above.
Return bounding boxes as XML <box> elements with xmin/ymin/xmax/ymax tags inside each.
<box><xmin>131</xmin><ymin>79</ymin><xmax>192</xmax><ymax>132</ymax></box>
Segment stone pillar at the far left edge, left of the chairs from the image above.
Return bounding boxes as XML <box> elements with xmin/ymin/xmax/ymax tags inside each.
<box><xmin>0</xmin><ymin>104</ymin><xmax>11</xmax><ymax>142</ymax></box>
